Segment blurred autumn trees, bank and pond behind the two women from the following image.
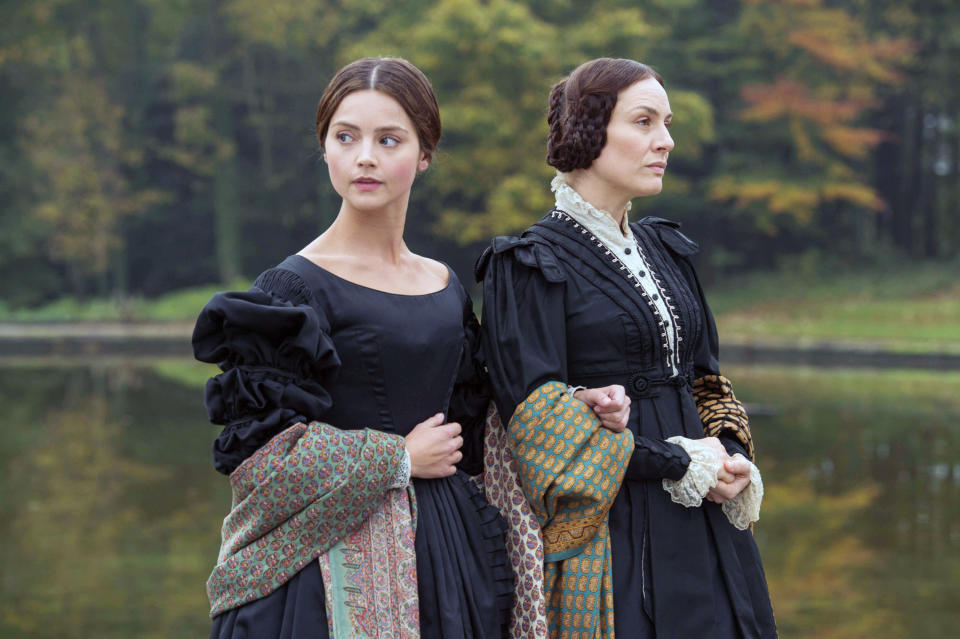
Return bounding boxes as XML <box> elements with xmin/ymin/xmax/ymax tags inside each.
<box><xmin>0</xmin><ymin>0</ymin><xmax>960</xmax><ymax>638</ymax></box>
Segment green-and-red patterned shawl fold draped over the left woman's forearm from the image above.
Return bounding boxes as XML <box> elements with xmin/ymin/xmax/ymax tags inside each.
<box><xmin>207</xmin><ymin>422</ymin><xmax>404</xmax><ymax>617</ymax></box>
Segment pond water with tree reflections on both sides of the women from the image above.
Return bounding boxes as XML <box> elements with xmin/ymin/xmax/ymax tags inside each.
<box><xmin>0</xmin><ymin>362</ymin><xmax>960</xmax><ymax>639</ymax></box>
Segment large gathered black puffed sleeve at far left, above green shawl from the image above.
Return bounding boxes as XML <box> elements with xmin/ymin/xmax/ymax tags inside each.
<box><xmin>193</xmin><ymin>269</ymin><xmax>340</xmax><ymax>474</ymax></box>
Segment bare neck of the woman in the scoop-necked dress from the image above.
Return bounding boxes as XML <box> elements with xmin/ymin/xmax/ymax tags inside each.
<box><xmin>316</xmin><ymin>202</ymin><xmax>410</xmax><ymax>264</ymax></box>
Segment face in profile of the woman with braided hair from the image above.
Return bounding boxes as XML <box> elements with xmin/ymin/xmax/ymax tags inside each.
<box><xmin>587</xmin><ymin>78</ymin><xmax>673</xmax><ymax>201</ymax></box>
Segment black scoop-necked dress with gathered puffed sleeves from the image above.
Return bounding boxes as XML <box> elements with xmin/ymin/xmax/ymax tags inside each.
<box><xmin>194</xmin><ymin>255</ymin><xmax>512</xmax><ymax>639</ymax></box>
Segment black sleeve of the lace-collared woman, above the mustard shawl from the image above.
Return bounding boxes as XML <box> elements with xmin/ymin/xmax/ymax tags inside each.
<box><xmin>476</xmin><ymin>237</ymin><xmax>568</xmax><ymax>424</ymax></box>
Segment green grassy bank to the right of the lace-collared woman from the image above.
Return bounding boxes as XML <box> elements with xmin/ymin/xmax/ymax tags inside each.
<box><xmin>707</xmin><ymin>261</ymin><xmax>960</xmax><ymax>353</ymax></box>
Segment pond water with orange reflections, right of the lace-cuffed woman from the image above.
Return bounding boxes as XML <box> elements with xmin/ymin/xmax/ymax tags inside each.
<box><xmin>728</xmin><ymin>368</ymin><xmax>960</xmax><ymax>638</ymax></box>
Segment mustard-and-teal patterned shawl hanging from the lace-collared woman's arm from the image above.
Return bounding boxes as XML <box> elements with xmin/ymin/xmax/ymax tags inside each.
<box><xmin>507</xmin><ymin>382</ymin><xmax>633</xmax><ymax>639</ymax></box>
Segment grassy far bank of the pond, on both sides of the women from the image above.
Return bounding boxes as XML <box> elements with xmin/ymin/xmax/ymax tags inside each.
<box><xmin>0</xmin><ymin>260</ymin><xmax>960</xmax><ymax>353</ymax></box>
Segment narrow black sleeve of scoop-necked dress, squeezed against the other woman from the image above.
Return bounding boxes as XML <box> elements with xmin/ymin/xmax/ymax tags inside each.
<box><xmin>447</xmin><ymin>287</ymin><xmax>490</xmax><ymax>475</ymax></box>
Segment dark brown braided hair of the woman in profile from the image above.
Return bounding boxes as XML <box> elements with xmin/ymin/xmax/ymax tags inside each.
<box><xmin>547</xmin><ymin>58</ymin><xmax>663</xmax><ymax>173</ymax></box>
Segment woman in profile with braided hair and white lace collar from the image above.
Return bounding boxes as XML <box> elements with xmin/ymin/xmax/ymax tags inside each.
<box><xmin>478</xmin><ymin>58</ymin><xmax>776</xmax><ymax>639</ymax></box>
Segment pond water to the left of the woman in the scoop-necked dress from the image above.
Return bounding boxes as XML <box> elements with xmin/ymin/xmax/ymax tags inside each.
<box><xmin>0</xmin><ymin>366</ymin><xmax>229</xmax><ymax>637</ymax></box>
